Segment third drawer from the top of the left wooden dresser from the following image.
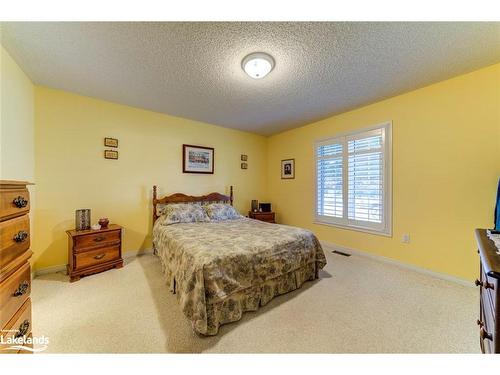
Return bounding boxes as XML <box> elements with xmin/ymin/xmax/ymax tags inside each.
<box><xmin>0</xmin><ymin>263</ymin><xmax>31</xmax><ymax>328</ymax></box>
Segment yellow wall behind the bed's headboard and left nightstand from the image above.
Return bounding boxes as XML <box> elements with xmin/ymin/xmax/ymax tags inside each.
<box><xmin>33</xmin><ymin>87</ymin><xmax>266</xmax><ymax>269</ymax></box>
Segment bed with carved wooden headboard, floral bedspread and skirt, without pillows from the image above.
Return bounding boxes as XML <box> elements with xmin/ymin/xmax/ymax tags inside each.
<box><xmin>153</xmin><ymin>186</ymin><xmax>326</xmax><ymax>335</ymax></box>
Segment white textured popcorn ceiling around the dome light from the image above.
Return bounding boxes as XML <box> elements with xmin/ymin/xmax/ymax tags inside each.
<box><xmin>2</xmin><ymin>22</ymin><xmax>500</xmax><ymax>135</ymax></box>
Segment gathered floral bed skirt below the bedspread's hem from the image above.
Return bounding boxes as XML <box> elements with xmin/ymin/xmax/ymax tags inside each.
<box><xmin>198</xmin><ymin>262</ymin><xmax>318</xmax><ymax>336</ymax></box>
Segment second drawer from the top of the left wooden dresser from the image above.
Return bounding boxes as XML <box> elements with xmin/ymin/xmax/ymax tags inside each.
<box><xmin>0</xmin><ymin>215</ymin><xmax>30</xmax><ymax>268</ymax></box>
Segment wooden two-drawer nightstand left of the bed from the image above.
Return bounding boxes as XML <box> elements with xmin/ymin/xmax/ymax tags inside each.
<box><xmin>66</xmin><ymin>224</ymin><xmax>123</xmax><ymax>282</ymax></box>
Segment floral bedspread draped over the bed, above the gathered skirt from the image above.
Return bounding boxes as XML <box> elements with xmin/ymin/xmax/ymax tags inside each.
<box><xmin>153</xmin><ymin>218</ymin><xmax>326</xmax><ymax>334</ymax></box>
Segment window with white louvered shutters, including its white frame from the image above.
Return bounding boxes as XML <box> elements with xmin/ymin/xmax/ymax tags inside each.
<box><xmin>315</xmin><ymin>123</ymin><xmax>392</xmax><ymax>235</ymax></box>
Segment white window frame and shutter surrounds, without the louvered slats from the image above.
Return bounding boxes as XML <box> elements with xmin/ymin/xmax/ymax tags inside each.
<box><xmin>313</xmin><ymin>121</ymin><xmax>392</xmax><ymax>237</ymax></box>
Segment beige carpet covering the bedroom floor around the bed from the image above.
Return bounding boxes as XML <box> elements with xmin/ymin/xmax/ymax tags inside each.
<box><xmin>32</xmin><ymin>252</ymin><xmax>479</xmax><ymax>353</ymax></box>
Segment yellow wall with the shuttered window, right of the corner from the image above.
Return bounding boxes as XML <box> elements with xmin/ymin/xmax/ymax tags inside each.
<box><xmin>268</xmin><ymin>64</ymin><xmax>500</xmax><ymax>280</ymax></box>
